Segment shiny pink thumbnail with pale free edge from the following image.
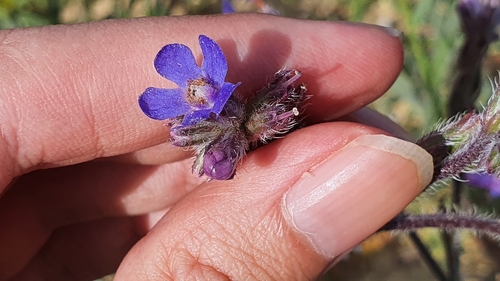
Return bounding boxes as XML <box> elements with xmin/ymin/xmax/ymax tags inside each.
<box><xmin>284</xmin><ymin>135</ymin><xmax>433</xmax><ymax>258</ymax></box>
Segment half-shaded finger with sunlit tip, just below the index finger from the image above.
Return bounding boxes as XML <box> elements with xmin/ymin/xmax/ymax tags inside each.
<box><xmin>0</xmin><ymin>161</ymin><xmax>202</xmax><ymax>280</ymax></box>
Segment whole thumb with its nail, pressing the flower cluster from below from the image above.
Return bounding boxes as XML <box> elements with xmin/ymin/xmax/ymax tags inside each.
<box><xmin>116</xmin><ymin>122</ymin><xmax>432</xmax><ymax>280</ymax></box>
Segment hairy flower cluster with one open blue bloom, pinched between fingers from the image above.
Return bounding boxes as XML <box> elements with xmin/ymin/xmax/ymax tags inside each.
<box><xmin>139</xmin><ymin>35</ymin><xmax>307</xmax><ymax>180</ymax></box>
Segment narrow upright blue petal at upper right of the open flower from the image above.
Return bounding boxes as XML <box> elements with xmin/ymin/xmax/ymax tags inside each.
<box><xmin>198</xmin><ymin>35</ymin><xmax>227</xmax><ymax>86</ymax></box>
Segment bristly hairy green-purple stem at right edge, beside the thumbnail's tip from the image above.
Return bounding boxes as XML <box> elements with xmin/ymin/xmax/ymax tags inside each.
<box><xmin>417</xmin><ymin>76</ymin><xmax>500</xmax><ymax>186</ymax></box>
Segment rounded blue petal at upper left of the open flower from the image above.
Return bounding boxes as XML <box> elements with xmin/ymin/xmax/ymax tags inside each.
<box><xmin>154</xmin><ymin>44</ymin><xmax>201</xmax><ymax>88</ymax></box>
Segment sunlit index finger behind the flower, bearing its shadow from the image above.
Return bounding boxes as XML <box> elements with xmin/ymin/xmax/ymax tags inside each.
<box><xmin>0</xmin><ymin>14</ymin><xmax>402</xmax><ymax>186</ymax></box>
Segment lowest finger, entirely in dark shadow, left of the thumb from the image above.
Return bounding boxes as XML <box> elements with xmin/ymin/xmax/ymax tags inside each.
<box><xmin>10</xmin><ymin>215</ymin><xmax>145</xmax><ymax>281</ymax></box>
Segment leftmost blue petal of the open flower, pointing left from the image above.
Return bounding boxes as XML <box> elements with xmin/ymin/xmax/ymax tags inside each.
<box><xmin>139</xmin><ymin>87</ymin><xmax>191</xmax><ymax>120</ymax></box>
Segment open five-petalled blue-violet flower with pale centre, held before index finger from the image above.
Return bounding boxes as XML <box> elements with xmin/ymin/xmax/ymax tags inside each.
<box><xmin>139</xmin><ymin>35</ymin><xmax>240</xmax><ymax>126</ymax></box>
